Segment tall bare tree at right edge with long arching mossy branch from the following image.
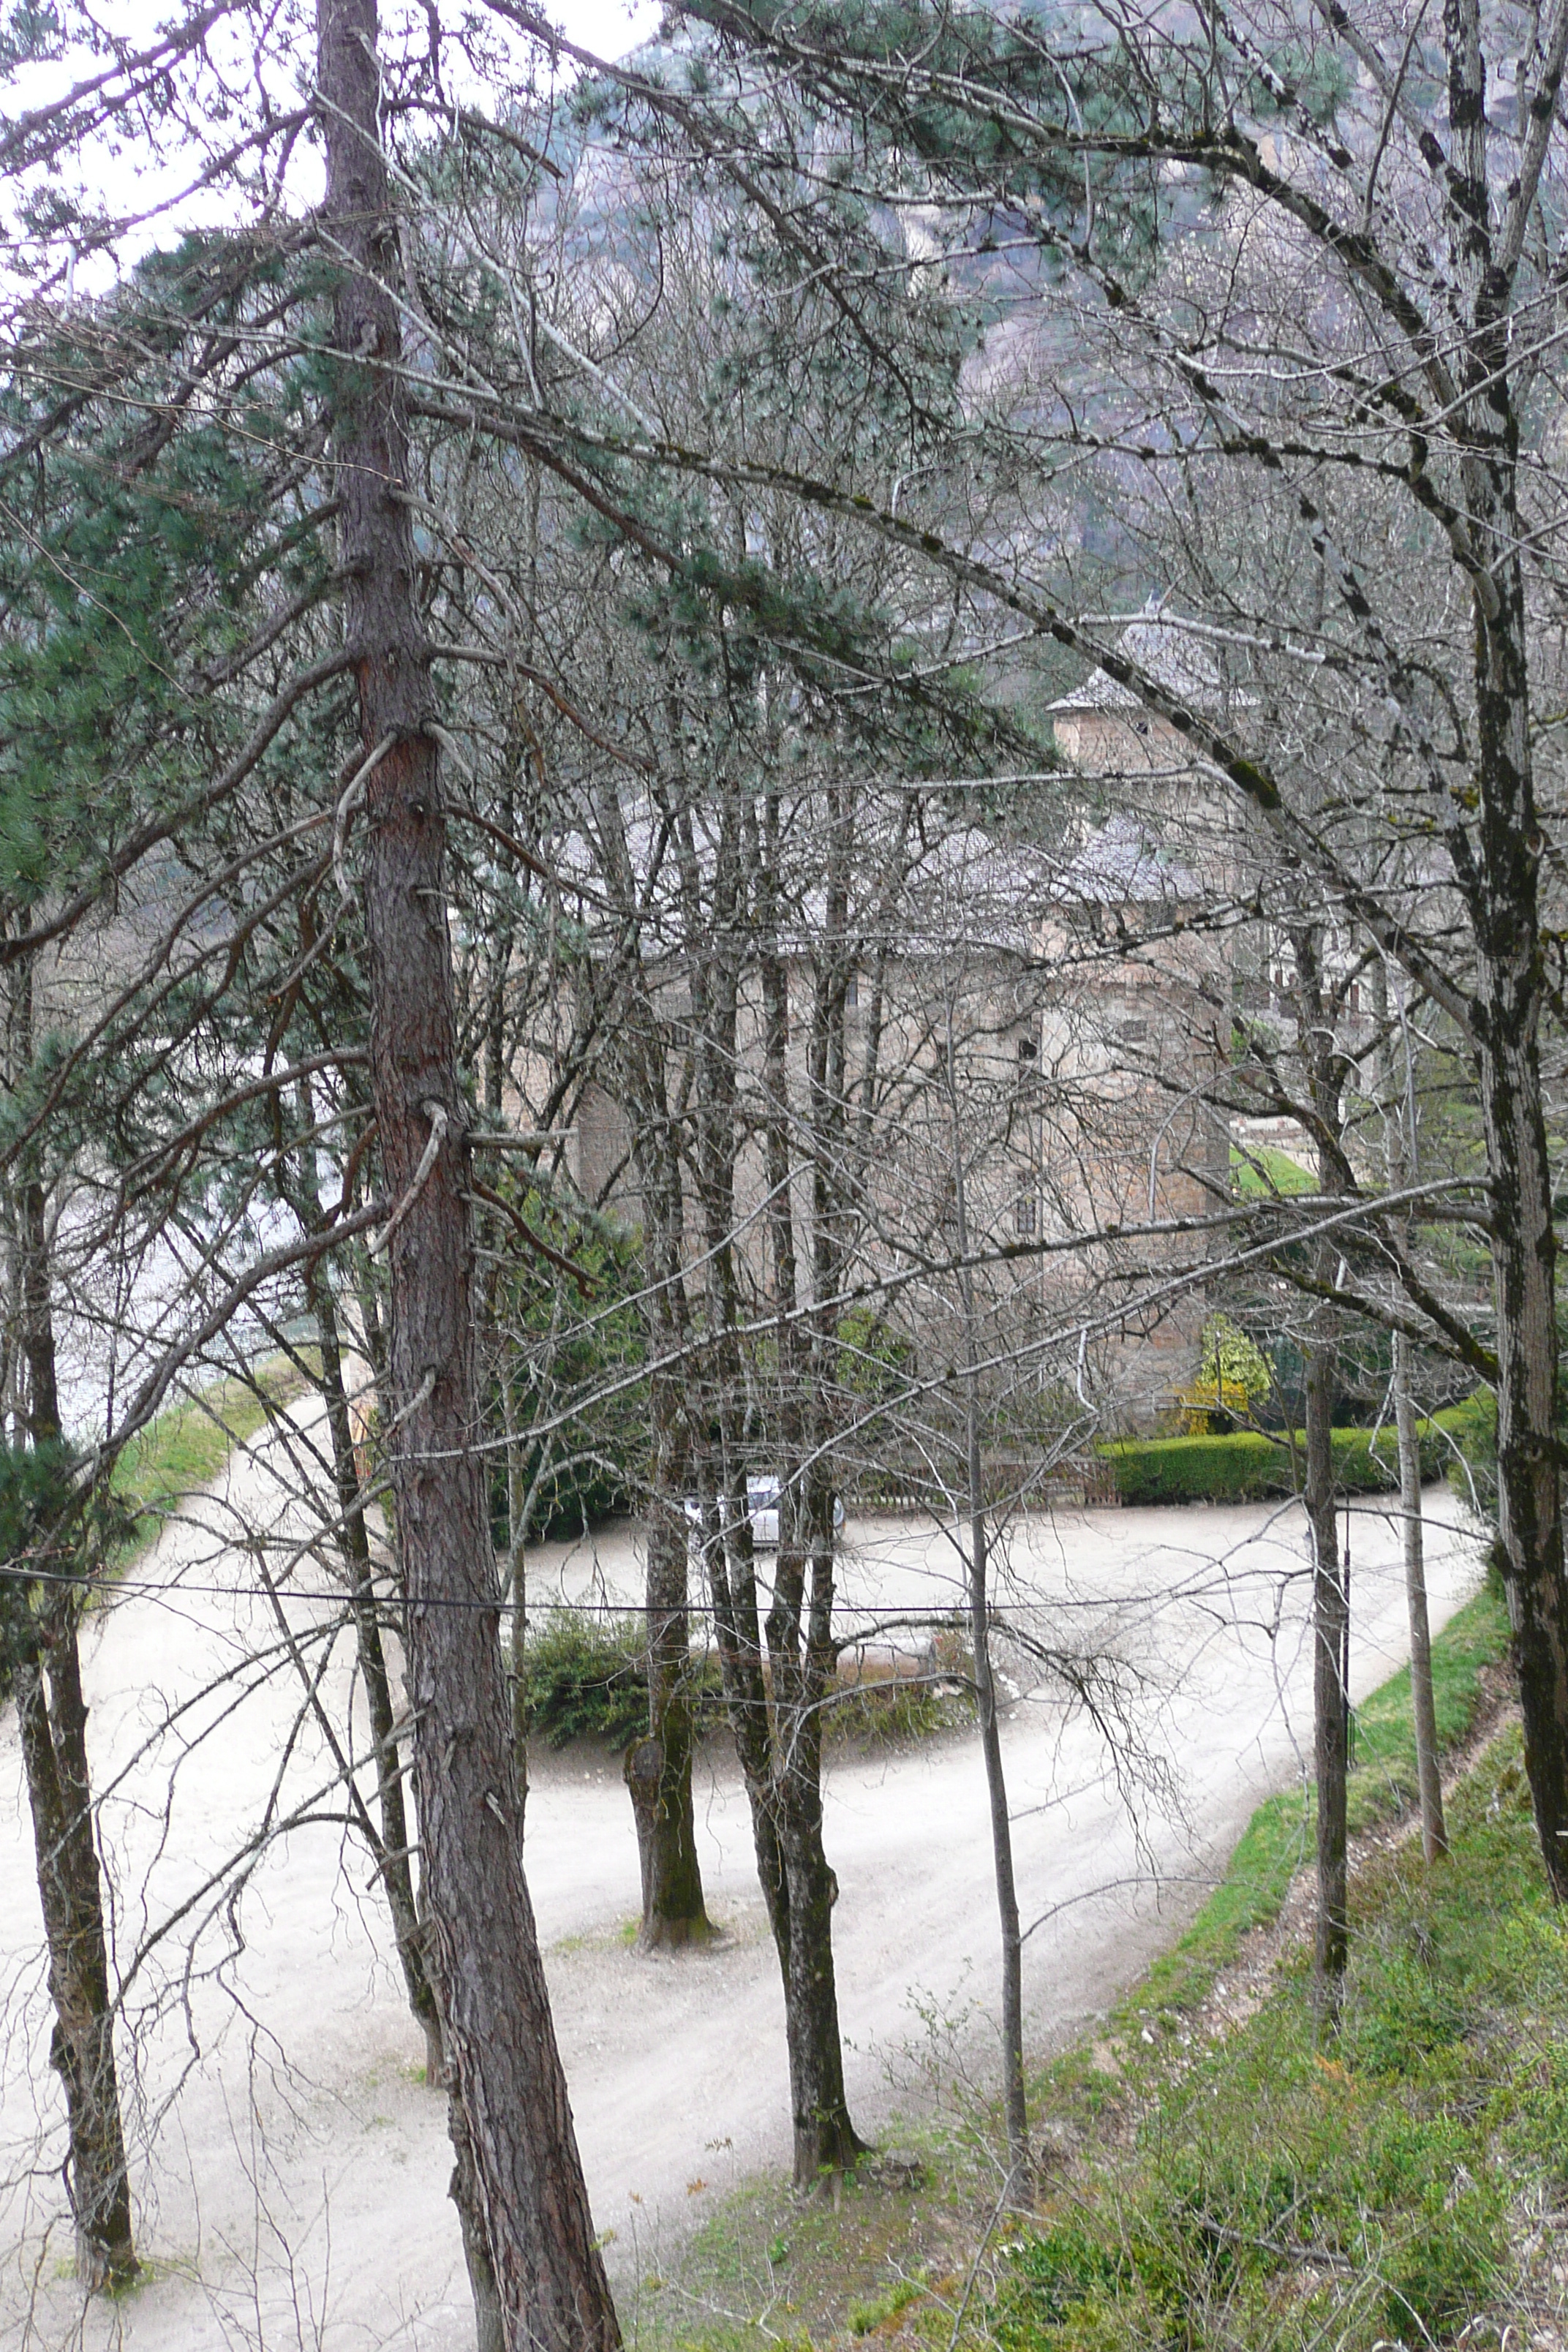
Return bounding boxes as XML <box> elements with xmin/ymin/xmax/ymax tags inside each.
<box><xmin>630</xmin><ymin>0</ymin><xmax>1568</xmax><ymax>1896</ymax></box>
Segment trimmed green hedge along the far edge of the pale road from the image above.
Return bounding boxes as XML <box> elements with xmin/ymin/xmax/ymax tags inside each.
<box><xmin>1098</xmin><ymin>1390</ymin><xmax>1495</xmax><ymax>1503</ymax></box>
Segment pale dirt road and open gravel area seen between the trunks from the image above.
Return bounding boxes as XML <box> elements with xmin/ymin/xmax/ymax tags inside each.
<box><xmin>0</xmin><ymin>1411</ymin><xmax>1479</xmax><ymax>2352</ymax></box>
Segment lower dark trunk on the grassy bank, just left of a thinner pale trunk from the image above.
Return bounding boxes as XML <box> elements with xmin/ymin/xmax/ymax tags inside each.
<box><xmin>1307</xmin><ymin>1341</ymin><xmax>1349</xmax><ymax>2029</ymax></box>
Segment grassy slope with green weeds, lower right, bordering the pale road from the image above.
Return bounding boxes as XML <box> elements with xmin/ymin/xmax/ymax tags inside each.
<box><xmin>618</xmin><ymin>1592</ymin><xmax>1542</xmax><ymax>2352</ymax></box>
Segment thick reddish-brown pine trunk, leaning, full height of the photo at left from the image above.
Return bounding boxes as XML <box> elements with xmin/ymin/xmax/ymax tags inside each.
<box><xmin>317</xmin><ymin>0</ymin><xmax>621</xmax><ymax>2352</ymax></box>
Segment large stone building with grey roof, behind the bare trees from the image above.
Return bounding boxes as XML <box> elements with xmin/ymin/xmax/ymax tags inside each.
<box><xmin>540</xmin><ymin>753</ymin><xmax>1227</xmax><ymax>1425</ymax></box>
